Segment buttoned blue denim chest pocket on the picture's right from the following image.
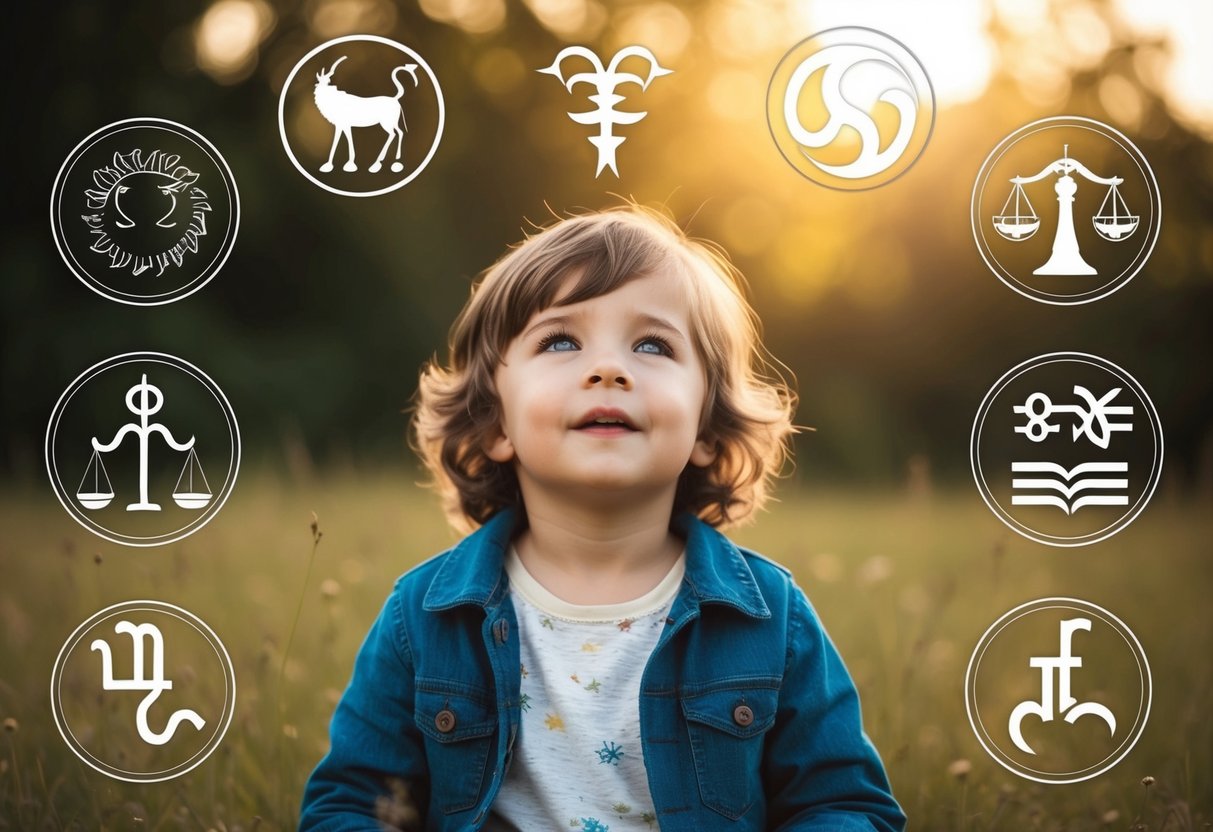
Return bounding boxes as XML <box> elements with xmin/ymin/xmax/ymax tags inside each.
<box><xmin>682</xmin><ymin>678</ymin><xmax>779</xmax><ymax>820</ymax></box>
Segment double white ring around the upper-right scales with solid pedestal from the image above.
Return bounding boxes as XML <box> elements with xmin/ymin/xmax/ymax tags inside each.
<box><xmin>969</xmin><ymin>115</ymin><xmax>1162</xmax><ymax>306</ymax></box>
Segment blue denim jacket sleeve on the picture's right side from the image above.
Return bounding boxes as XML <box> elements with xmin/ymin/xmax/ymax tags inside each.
<box><xmin>763</xmin><ymin>583</ymin><xmax>906</xmax><ymax>832</ymax></box>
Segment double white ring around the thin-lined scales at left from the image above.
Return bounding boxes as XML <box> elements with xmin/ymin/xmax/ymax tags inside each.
<box><xmin>45</xmin><ymin>352</ymin><xmax>240</xmax><ymax>548</ymax></box>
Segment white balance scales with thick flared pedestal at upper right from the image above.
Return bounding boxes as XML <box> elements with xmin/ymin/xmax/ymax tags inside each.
<box><xmin>993</xmin><ymin>144</ymin><xmax>1141</xmax><ymax>275</ymax></box>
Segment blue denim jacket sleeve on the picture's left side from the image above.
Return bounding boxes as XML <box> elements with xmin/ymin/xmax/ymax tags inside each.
<box><xmin>300</xmin><ymin>592</ymin><xmax>429</xmax><ymax>832</ymax></box>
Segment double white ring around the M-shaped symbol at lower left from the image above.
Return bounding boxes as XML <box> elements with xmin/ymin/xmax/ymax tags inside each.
<box><xmin>51</xmin><ymin>599</ymin><xmax>235</xmax><ymax>783</ymax></box>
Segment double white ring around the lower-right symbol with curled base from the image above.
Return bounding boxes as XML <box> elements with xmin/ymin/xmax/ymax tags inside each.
<box><xmin>964</xmin><ymin>595</ymin><xmax>1154</xmax><ymax>786</ymax></box>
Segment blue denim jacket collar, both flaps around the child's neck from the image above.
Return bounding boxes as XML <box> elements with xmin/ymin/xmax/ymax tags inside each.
<box><xmin>422</xmin><ymin>508</ymin><xmax>770</xmax><ymax>619</ymax></box>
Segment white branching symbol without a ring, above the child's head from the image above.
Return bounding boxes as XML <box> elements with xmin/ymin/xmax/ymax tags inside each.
<box><xmin>537</xmin><ymin>46</ymin><xmax>673</xmax><ymax>178</ymax></box>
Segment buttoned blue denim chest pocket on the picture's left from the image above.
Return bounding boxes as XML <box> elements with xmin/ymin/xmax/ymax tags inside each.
<box><xmin>414</xmin><ymin>678</ymin><xmax>497</xmax><ymax>814</ymax></box>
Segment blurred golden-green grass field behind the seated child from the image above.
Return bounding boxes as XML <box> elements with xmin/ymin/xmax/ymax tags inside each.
<box><xmin>0</xmin><ymin>473</ymin><xmax>1213</xmax><ymax>832</ymax></box>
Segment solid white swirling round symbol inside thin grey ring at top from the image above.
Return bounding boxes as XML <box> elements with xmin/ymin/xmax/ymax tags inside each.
<box><xmin>784</xmin><ymin>44</ymin><xmax>918</xmax><ymax>179</ymax></box>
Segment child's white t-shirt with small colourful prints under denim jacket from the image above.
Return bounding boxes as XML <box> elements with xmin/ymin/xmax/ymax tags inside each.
<box><xmin>485</xmin><ymin>549</ymin><xmax>687</xmax><ymax>832</ymax></box>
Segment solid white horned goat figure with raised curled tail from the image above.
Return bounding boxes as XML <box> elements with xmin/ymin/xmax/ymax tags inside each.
<box><xmin>315</xmin><ymin>55</ymin><xmax>420</xmax><ymax>173</ymax></box>
